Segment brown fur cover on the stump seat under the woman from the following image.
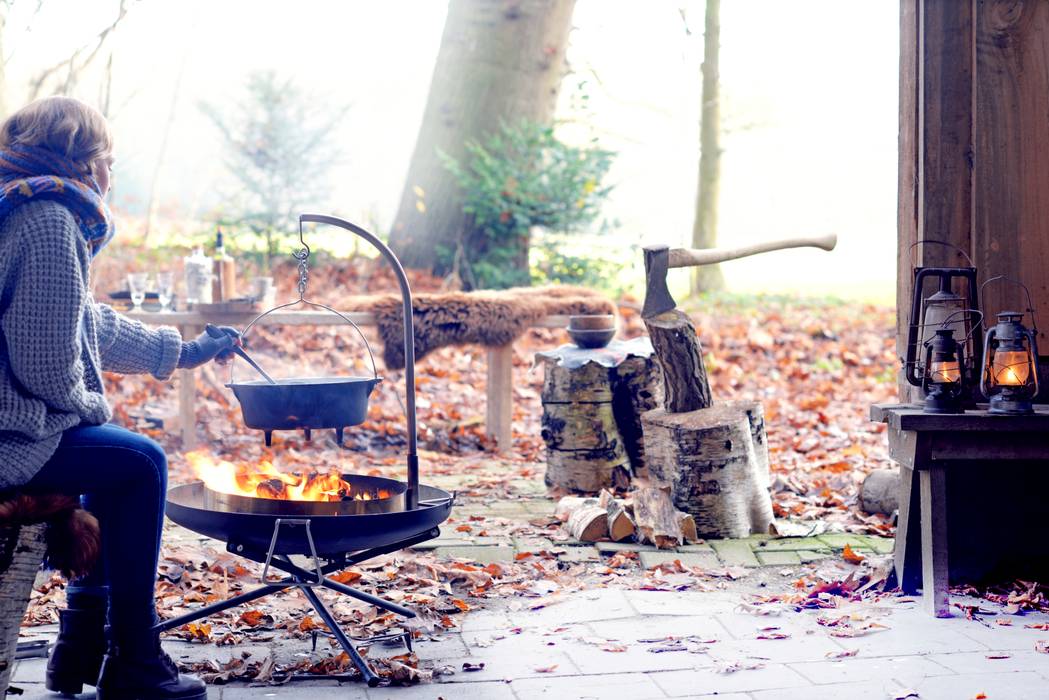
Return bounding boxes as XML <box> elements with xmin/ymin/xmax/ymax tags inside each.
<box><xmin>0</xmin><ymin>493</ymin><xmax>101</xmax><ymax>578</ymax></box>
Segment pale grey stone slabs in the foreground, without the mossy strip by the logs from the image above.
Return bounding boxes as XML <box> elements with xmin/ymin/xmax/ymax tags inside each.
<box><xmin>15</xmin><ymin>587</ymin><xmax>1049</xmax><ymax>700</ymax></box>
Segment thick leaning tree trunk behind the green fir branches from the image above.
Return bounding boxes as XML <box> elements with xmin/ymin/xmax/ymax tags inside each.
<box><xmin>389</xmin><ymin>0</ymin><xmax>575</xmax><ymax>275</ymax></box>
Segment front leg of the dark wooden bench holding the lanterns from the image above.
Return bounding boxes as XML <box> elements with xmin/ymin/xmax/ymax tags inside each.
<box><xmin>919</xmin><ymin>467</ymin><xmax>950</xmax><ymax>617</ymax></box>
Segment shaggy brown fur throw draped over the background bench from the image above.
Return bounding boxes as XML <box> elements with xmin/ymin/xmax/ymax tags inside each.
<box><xmin>339</xmin><ymin>285</ymin><xmax>616</xmax><ymax>369</ymax></box>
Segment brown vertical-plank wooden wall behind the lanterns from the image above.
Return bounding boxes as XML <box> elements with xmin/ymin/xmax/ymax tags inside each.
<box><xmin>897</xmin><ymin>0</ymin><xmax>1049</xmax><ymax>400</ymax></box>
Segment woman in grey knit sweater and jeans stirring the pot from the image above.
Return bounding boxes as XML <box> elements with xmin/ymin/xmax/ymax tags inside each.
<box><xmin>0</xmin><ymin>97</ymin><xmax>239</xmax><ymax>700</ymax></box>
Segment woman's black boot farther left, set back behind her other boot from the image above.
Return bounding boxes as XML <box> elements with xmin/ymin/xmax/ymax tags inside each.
<box><xmin>44</xmin><ymin>607</ymin><xmax>106</xmax><ymax>695</ymax></box>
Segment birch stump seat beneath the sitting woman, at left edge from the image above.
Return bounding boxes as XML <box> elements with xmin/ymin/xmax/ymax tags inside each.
<box><xmin>0</xmin><ymin>524</ymin><xmax>47</xmax><ymax>698</ymax></box>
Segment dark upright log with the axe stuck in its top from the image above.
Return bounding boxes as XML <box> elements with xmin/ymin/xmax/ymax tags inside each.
<box><xmin>645</xmin><ymin>309</ymin><xmax>713</xmax><ymax>413</ymax></box>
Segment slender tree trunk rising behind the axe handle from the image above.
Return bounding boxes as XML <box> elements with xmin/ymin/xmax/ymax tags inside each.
<box><xmin>692</xmin><ymin>0</ymin><xmax>725</xmax><ymax>294</ymax></box>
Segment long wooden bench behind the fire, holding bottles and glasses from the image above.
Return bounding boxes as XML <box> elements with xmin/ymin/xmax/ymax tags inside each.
<box><xmin>125</xmin><ymin>311</ymin><xmax>569</xmax><ymax>449</ymax></box>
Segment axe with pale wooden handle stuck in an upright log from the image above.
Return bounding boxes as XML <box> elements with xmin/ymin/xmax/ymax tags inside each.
<box><xmin>641</xmin><ymin>233</ymin><xmax>838</xmax><ymax>318</ymax></box>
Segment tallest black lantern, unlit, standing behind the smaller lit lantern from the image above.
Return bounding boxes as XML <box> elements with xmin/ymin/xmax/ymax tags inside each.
<box><xmin>904</xmin><ymin>240</ymin><xmax>983</xmax><ymax>394</ymax></box>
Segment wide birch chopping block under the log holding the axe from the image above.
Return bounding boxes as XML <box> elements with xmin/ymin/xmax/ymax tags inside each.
<box><xmin>638</xmin><ymin>401</ymin><xmax>773</xmax><ymax>537</ymax></box>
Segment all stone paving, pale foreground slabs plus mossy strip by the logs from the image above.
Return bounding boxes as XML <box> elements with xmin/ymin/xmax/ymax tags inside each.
<box><xmin>15</xmin><ymin>494</ymin><xmax>1049</xmax><ymax>700</ymax></box>
